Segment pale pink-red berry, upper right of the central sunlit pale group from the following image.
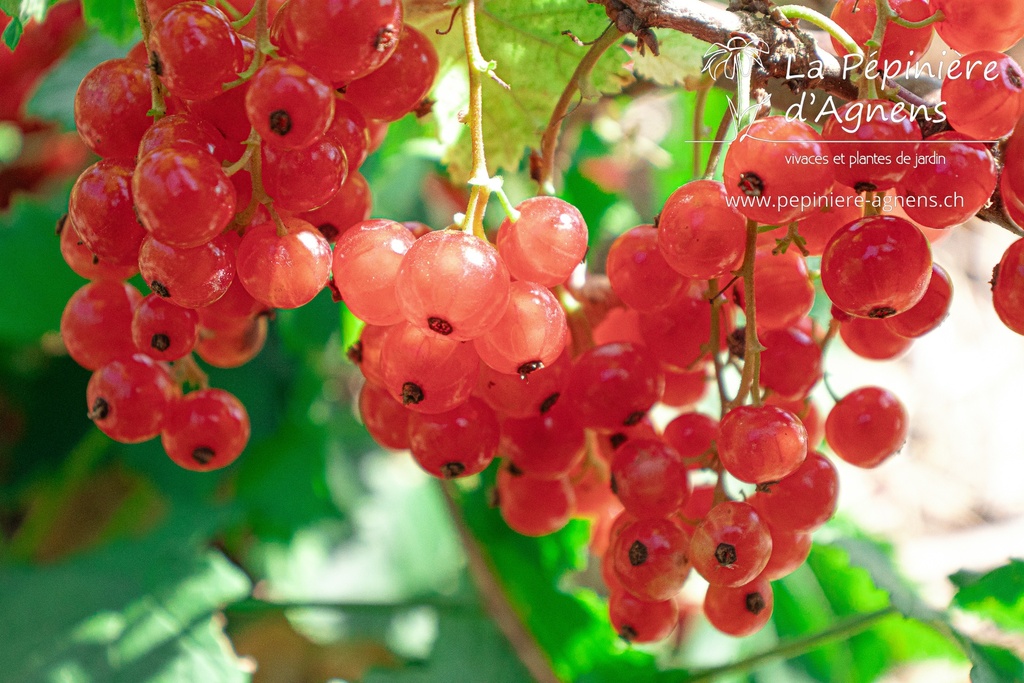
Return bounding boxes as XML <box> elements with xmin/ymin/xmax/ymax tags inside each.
<box><xmin>498</xmin><ymin>197</ymin><xmax>588</xmax><ymax>287</ymax></box>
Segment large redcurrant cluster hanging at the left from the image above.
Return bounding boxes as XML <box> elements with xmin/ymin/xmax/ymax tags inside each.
<box><xmin>58</xmin><ymin>0</ymin><xmax>437</xmax><ymax>470</ymax></box>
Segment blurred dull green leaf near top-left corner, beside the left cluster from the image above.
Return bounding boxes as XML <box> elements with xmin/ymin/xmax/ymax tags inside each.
<box><xmin>26</xmin><ymin>31</ymin><xmax>125</xmax><ymax>130</ymax></box>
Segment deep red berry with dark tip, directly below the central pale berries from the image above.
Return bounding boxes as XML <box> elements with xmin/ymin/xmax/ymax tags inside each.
<box><xmin>409</xmin><ymin>398</ymin><xmax>500</xmax><ymax>479</ymax></box>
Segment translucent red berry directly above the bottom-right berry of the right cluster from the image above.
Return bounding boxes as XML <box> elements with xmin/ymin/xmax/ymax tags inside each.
<box><xmin>690</xmin><ymin>501</ymin><xmax>771</xmax><ymax>586</ymax></box>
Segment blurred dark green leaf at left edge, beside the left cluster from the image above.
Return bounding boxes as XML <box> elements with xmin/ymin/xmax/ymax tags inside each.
<box><xmin>0</xmin><ymin>187</ymin><xmax>85</xmax><ymax>344</ymax></box>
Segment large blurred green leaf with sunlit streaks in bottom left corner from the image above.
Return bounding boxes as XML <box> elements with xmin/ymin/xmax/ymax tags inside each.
<box><xmin>0</xmin><ymin>509</ymin><xmax>251</xmax><ymax>683</ymax></box>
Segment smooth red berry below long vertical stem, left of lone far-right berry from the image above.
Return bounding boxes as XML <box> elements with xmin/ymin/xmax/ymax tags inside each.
<box><xmin>718</xmin><ymin>405</ymin><xmax>807</xmax><ymax>483</ymax></box>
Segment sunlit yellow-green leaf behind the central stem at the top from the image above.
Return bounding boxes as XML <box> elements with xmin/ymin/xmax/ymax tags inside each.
<box><xmin>425</xmin><ymin>0</ymin><xmax>627</xmax><ymax>183</ymax></box>
